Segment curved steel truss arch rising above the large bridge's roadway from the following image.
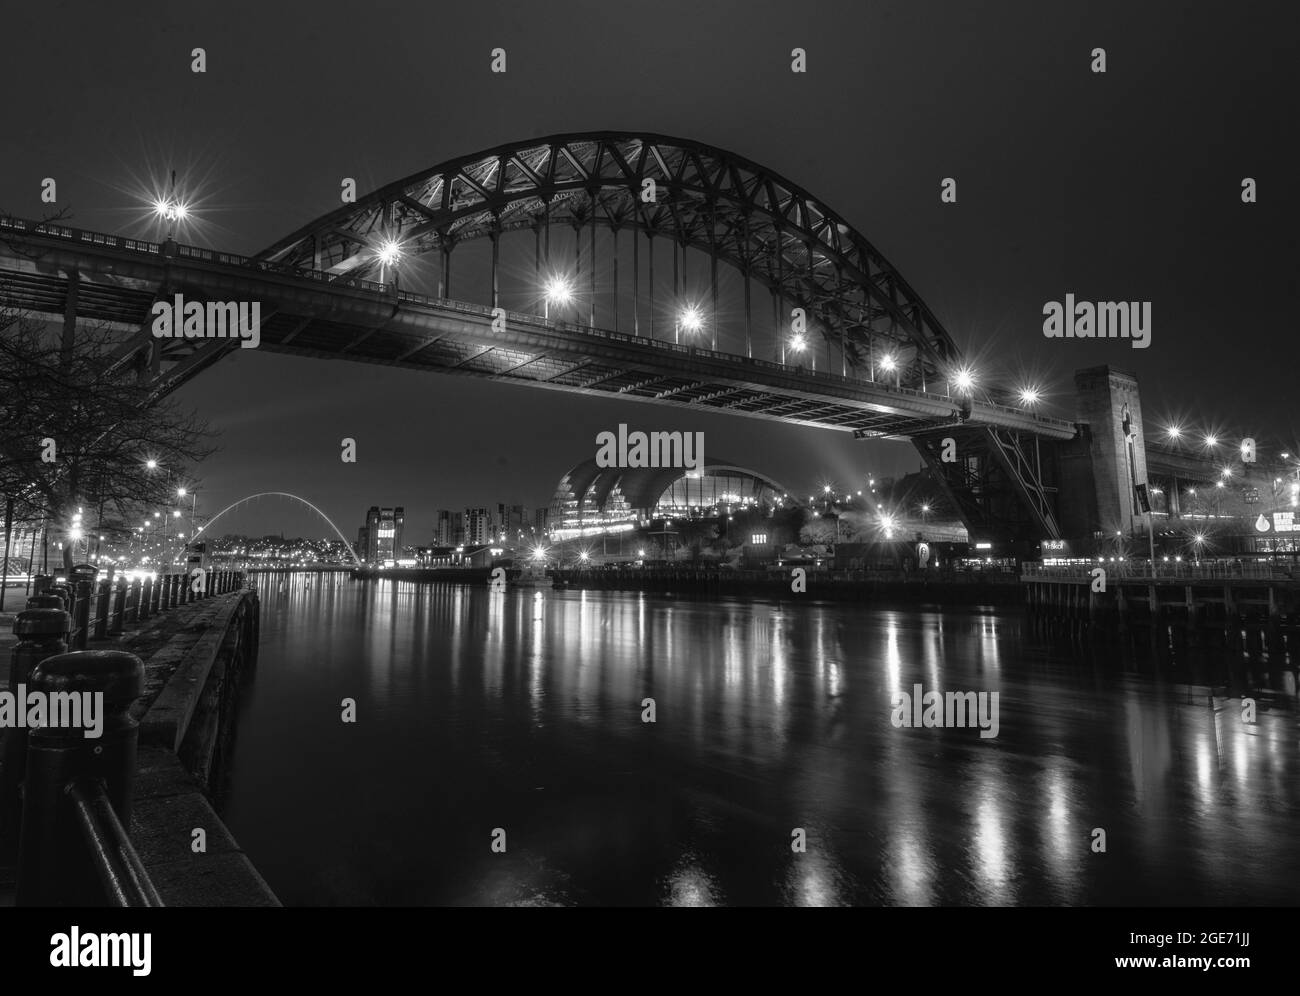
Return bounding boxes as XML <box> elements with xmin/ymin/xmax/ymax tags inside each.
<box><xmin>254</xmin><ymin>133</ymin><xmax>959</xmax><ymax>391</ymax></box>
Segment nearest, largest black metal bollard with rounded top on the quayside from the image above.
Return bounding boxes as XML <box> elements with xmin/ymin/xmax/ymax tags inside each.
<box><xmin>16</xmin><ymin>650</ymin><xmax>144</xmax><ymax>906</ymax></box>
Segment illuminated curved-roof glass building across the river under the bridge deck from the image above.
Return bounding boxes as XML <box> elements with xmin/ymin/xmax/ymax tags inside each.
<box><xmin>547</xmin><ymin>459</ymin><xmax>800</xmax><ymax>540</ymax></box>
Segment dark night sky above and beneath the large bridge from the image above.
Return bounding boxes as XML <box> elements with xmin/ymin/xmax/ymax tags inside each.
<box><xmin>0</xmin><ymin>0</ymin><xmax>1300</xmax><ymax>542</ymax></box>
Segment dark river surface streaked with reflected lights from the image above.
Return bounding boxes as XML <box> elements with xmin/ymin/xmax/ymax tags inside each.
<box><xmin>225</xmin><ymin>576</ymin><xmax>1300</xmax><ymax>905</ymax></box>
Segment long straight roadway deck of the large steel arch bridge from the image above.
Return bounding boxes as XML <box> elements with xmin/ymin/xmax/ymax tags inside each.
<box><xmin>0</xmin><ymin>217</ymin><xmax>1076</xmax><ymax>439</ymax></box>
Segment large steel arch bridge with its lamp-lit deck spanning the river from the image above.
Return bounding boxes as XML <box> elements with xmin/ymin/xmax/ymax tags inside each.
<box><xmin>0</xmin><ymin>133</ymin><xmax>1078</xmax><ymax>538</ymax></box>
